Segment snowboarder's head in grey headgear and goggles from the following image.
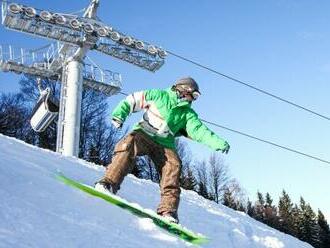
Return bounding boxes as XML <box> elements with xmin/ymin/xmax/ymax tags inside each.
<box><xmin>173</xmin><ymin>77</ymin><xmax>201</xmax><ymax>100</ymax></box>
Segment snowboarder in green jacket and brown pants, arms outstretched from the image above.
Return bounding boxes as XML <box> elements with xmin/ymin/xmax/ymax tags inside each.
<box><xmin>95</xmin><ymin>77</ymin><xmax>230</xmax><ymax>223</ymax></box>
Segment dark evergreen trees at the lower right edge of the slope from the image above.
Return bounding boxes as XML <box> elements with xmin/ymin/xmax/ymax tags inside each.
<box><xmin>245</xmin><ymin>190</ymin><xmax>330</xmax><ymax>248</ymax></box>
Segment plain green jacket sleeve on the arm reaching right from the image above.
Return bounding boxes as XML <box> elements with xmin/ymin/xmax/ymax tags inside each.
<box><xmin>186</xmin><ymin>110</ymin><xmax>228</xmax><ymax>150</ymax></box>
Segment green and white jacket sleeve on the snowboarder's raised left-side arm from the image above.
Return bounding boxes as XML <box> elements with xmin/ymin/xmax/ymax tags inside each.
<box><xmin>112</xmin><ymin>90</ymin><xmax>160</xmax><ymax>122</ymax></box>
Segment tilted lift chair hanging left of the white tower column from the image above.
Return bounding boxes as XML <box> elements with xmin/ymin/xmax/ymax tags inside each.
<box><xmin>30</xmin><ymin>78</ymin><xmax>59</xmax><ymax>132</ymax></box>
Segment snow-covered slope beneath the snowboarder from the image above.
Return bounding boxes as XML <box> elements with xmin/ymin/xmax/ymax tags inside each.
<box><xmin>0</xmin><ymin>135</ymin><xmax>311</xmax><ymax>248</ymax></box>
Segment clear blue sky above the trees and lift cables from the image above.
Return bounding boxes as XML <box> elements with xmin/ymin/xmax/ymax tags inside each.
<box><xmin>0</xmin><ymin>0</ymin><xmax>330</xmax><ymax>219</ymax></box>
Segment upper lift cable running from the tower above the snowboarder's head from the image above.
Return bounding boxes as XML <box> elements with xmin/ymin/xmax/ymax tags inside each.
<box><xmin>166</xmin><ymin>50</ymin><xmax>330</xmax><ymax>121</ymax></box>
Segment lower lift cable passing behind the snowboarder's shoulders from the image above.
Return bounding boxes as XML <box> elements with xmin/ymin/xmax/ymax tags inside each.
<box><xmin>119</xmin><ymin>91</ymin><xmax>330</xmax><ymax>164</ymax></box>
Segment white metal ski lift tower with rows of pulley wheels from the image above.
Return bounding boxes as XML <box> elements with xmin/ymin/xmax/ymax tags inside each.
<box><xmin>0</xmin><ymin>0</ymin><xmax>167</xmax><ymax>156</ymax></box>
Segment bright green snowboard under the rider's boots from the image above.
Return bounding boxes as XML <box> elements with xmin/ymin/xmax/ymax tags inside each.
<box><xmin>56</xmin><ymin>174</ymin><xmax>208</xmax><ymax>245</ymax></box>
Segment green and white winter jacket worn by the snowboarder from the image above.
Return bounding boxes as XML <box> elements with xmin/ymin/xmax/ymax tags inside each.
<box><xmin>112</xmin><ymin>88</ymin><xmax>228</xmax><ymax>150</ymax></box>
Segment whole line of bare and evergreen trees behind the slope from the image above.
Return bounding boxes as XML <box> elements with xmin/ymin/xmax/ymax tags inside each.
<box><xmin>0</xmin><ymin>76</ymin><xmax>330</xmax><ymax>248</ymax></box>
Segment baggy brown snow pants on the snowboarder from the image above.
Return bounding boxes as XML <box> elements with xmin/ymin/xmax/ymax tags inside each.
<box><xmin>103</xmin><ymin>131</ymin><xmax>181</xmax><ymax>214</ymax></box>
